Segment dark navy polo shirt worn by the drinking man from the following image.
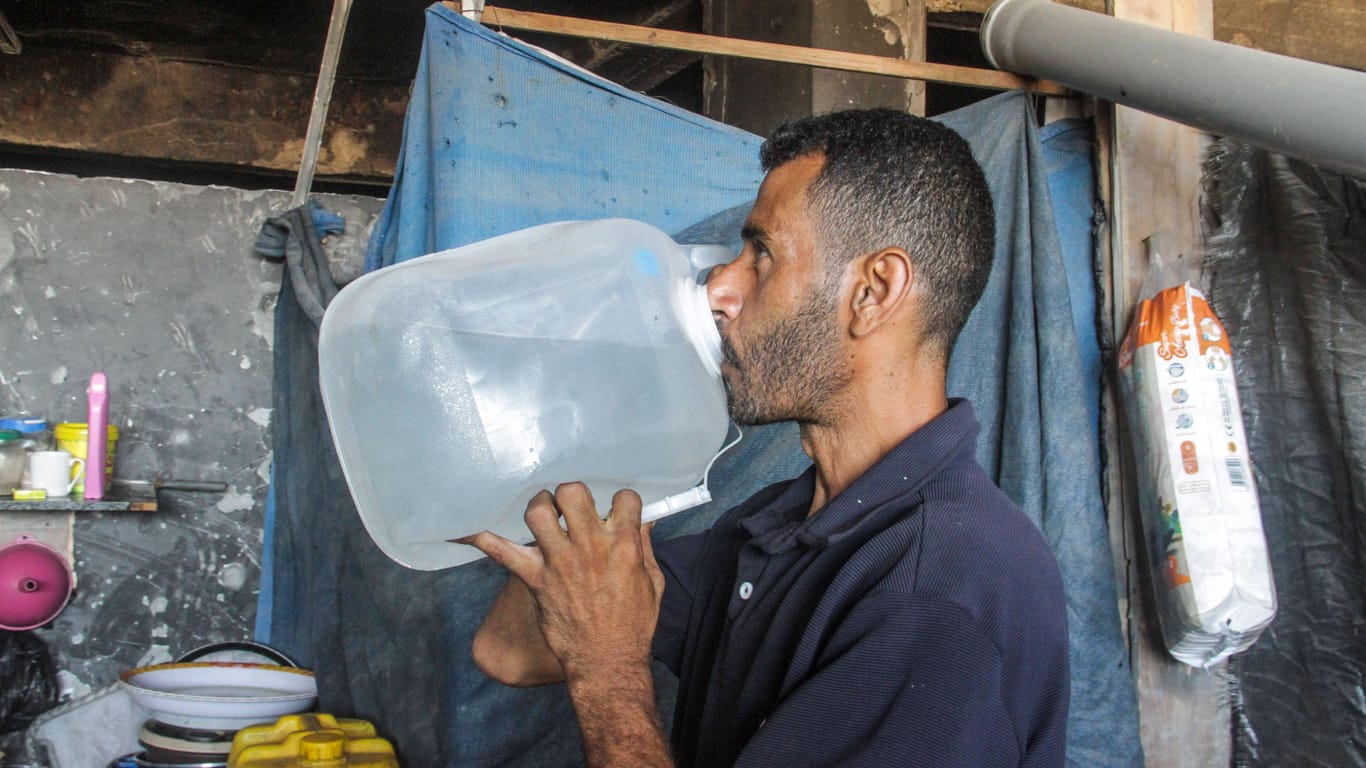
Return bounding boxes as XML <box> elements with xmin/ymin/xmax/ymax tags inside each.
<box><xmin>654</xmin><ymin>400</ymin><xmax>1068</xmax><ymax>768</ymax></box>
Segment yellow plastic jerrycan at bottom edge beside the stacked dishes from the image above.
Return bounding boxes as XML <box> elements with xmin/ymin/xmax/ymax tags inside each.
<box><xmin>228</xmin><ymin>713</ymin><xmax>399</xmax><ymax>768</ymax></box>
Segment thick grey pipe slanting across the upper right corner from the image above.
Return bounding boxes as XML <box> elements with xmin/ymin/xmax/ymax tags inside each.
<box><xmin>982</xmin><ymin>0</ymin><xmax>1366</xmax><ymax>176</ymax></box>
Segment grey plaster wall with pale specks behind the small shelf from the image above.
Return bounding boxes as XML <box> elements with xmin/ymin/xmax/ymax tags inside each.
<box><xmin>0</xmin><ymin>169</ymin><xmax>382</xmax><ymax>697</ymax></box>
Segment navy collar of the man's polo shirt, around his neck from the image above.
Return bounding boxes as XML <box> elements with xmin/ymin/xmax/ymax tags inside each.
<box><xmin>739</xmin><ymin>398</ymin><xmax>978</xmax><ymax>553</ymax></box>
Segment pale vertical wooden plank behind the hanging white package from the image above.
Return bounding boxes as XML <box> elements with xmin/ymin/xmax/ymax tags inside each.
<box><xmin>1104</xmin><ymin>0</ymin><xmax>1232</xmax><ymax>768</ymax></box>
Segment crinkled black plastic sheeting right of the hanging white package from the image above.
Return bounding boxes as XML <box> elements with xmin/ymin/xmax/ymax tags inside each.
<box><xmin>1205</xmin><ymin>141</ymin><xmax>1366</xmax><ymax>768</ymax></box>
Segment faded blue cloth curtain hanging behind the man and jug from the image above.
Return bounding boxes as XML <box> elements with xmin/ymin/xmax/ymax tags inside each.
<box><xmin>260</xmin><ymin>5</ymin><xmax>1142</xmax><ymax>767</ymax></box>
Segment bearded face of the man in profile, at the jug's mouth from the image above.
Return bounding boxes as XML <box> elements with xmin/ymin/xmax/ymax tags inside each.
<box><xmin>708</xmin><ymin>156</ymin><xmax>850</xmax><ymax>424</ymax></box>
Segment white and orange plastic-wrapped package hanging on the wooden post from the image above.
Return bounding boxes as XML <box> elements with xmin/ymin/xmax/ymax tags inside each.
<box><xmin>1119</xmin><ymin>237</ymin><xmax>1276</xmax><ymax>667</ymax></box>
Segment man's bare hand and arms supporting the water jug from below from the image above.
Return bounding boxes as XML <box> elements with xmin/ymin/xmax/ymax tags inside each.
<box><xmin>467</xmin><ymin>482</ymin><xmax>673</xmax><ymax>768</ymax></box>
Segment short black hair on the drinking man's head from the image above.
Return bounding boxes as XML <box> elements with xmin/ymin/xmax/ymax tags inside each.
<box><xmin>759</xmin><ymin>109</ymin><xmax>996</xmax><ymax>361</ymax></box>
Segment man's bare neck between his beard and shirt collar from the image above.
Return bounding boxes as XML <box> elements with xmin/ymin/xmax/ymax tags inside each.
<box><xmin>802</xmin><ymin>363</ymin><xmax>948</xmax><ymax>515</ymax></box>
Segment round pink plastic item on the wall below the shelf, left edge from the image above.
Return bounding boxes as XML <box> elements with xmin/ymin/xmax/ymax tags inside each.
<box><xmin>0</xmin><ymin>536</ymin><xmax>74</xmax><ymax>631</ymax></box>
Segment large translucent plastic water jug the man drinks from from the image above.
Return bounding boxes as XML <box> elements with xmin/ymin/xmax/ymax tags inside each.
<box><xmin>318</xmin><ymin>219</ymin><xmax>732</xmax><ymax>570</ymax></box>
